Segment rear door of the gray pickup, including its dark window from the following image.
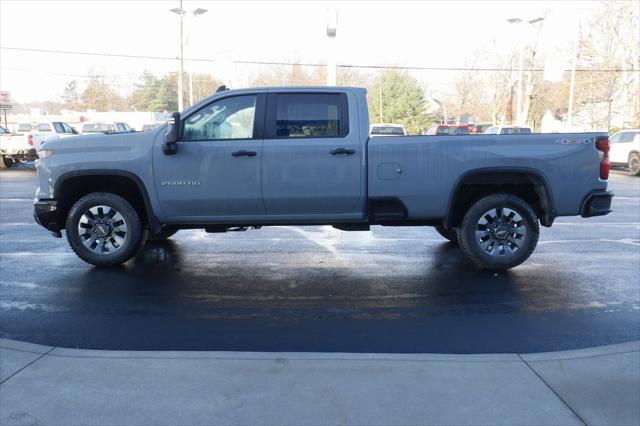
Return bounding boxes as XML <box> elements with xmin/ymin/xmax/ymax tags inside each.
<box><xmin>262</xmin><ymin>91</ymin><xmax>364</xmax><ymax>219</ymax></box>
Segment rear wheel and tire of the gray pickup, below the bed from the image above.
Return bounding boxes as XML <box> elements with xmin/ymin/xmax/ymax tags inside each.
<box><xmin>459</xmin><ymin>194</ymin><xmax>540</xmax><ymax>270</ymax></box>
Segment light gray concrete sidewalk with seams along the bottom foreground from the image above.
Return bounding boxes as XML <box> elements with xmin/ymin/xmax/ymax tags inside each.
<box><xmin>0</xmin><ymin>339</ymin><xmax>640</xmax><ymax>426</ymax></box>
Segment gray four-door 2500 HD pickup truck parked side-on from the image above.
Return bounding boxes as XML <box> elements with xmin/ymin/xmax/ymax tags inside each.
<box><xmin>34</xmin><ymin>87</ymin><xmax>613</xmax><ymax>269</ymax></box>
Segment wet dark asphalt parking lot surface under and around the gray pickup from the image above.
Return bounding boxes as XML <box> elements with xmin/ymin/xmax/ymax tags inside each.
<box><xmin>0</xmin><ymin>168</ymin><xmax>640</xmax><ymax>353</ymax></box>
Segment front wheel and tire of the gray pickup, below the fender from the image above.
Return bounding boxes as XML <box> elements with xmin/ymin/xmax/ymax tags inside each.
<box><xmin>66</xmin><ymin>192</ymin><xmax>147</xmax><ymax>266</ymax></box>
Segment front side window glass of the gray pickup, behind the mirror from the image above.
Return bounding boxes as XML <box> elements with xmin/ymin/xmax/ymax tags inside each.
<box><xmin>182</xmin><ymin>95</ymin><xmax>257</xmax><ymax>141</ymax></box>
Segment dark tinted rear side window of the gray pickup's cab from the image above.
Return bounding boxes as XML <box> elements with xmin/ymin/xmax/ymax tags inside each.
<box><xmin>268</xmin><ymin>93</ymin><xmax>349</xmax><ymax>139</ymax></box>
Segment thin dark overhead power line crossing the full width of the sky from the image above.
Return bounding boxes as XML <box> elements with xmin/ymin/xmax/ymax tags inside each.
<box><xmin>0</xmin><ymin>46</ymin><xmax>639</xmax><ymax>72</ymax></box>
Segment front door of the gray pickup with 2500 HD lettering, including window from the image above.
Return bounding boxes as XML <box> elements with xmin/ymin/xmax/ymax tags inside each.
<box><xmin>153</xmin><ymin>94</ymin><xmax>265</xmax><ymax>222</ymax></box>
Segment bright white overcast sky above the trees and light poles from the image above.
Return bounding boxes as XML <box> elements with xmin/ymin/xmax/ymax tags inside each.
<box><xmin>0</xmin><ymin>0</ymin><xmax>598</xmax><ymax>102</ymax></box>
